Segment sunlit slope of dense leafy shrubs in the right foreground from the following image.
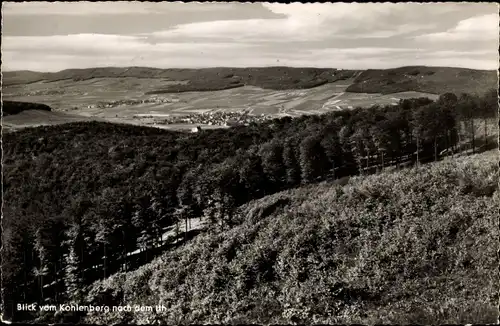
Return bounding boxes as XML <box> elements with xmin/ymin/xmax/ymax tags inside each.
<box><xmin>86</xmin><ymin>150</ymin><xmax>500</xmax><ymax>324</ymax></box>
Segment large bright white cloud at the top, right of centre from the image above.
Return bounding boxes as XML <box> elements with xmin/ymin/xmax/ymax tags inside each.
<box><xmin>145</xmin><ymin>3</ymin><xmax>458</xmax><ymax>43</ymax></box>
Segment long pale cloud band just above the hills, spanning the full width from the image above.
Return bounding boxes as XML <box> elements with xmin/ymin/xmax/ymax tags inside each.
<box><xmin>2</xmin><ymin>35</ymin><xmax>498</xmax><ymax>71</ymax></box>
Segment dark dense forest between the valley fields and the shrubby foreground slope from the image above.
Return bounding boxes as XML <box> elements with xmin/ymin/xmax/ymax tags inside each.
<box><xmin>1</xmin><ymin>89</ymin><xmax>498</xmax><ymax>322</ymax></box>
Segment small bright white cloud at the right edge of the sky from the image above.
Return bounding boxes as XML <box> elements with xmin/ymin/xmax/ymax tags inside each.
<box><xmin>415</xmin><ymin>14</ymin><xmax>499</xmax><ymax>42</ymax></box>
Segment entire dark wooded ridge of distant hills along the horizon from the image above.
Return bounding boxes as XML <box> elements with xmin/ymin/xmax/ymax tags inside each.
<box><xmin>3</xmin><ymin>66</ymin><xmax>498</xmax><ymax>94</ymax></box>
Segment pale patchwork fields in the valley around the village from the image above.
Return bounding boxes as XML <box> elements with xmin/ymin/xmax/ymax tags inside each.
<box><xmin>3</xmin><ymin>74</ymin><xmax>437</xmax><ymax>129</ymax></box>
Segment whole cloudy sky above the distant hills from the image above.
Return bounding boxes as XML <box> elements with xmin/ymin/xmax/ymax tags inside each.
<box><xmin>1</xmin><ymin>1</ymin><xmax>499</xmax><ymax>71</ymax></box>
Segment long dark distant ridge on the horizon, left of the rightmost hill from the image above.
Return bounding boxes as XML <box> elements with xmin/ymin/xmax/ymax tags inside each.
<box><xmin>4</xmin><ymin>67</ymin><xmax>355</xmax><ymax>94</ymax></box>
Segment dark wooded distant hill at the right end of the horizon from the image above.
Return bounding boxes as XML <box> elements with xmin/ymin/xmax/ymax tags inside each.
<box><xmin>347</xmin><ymin>66</ymin><xmax>498</xmax><ymax>94</ymax></box>
